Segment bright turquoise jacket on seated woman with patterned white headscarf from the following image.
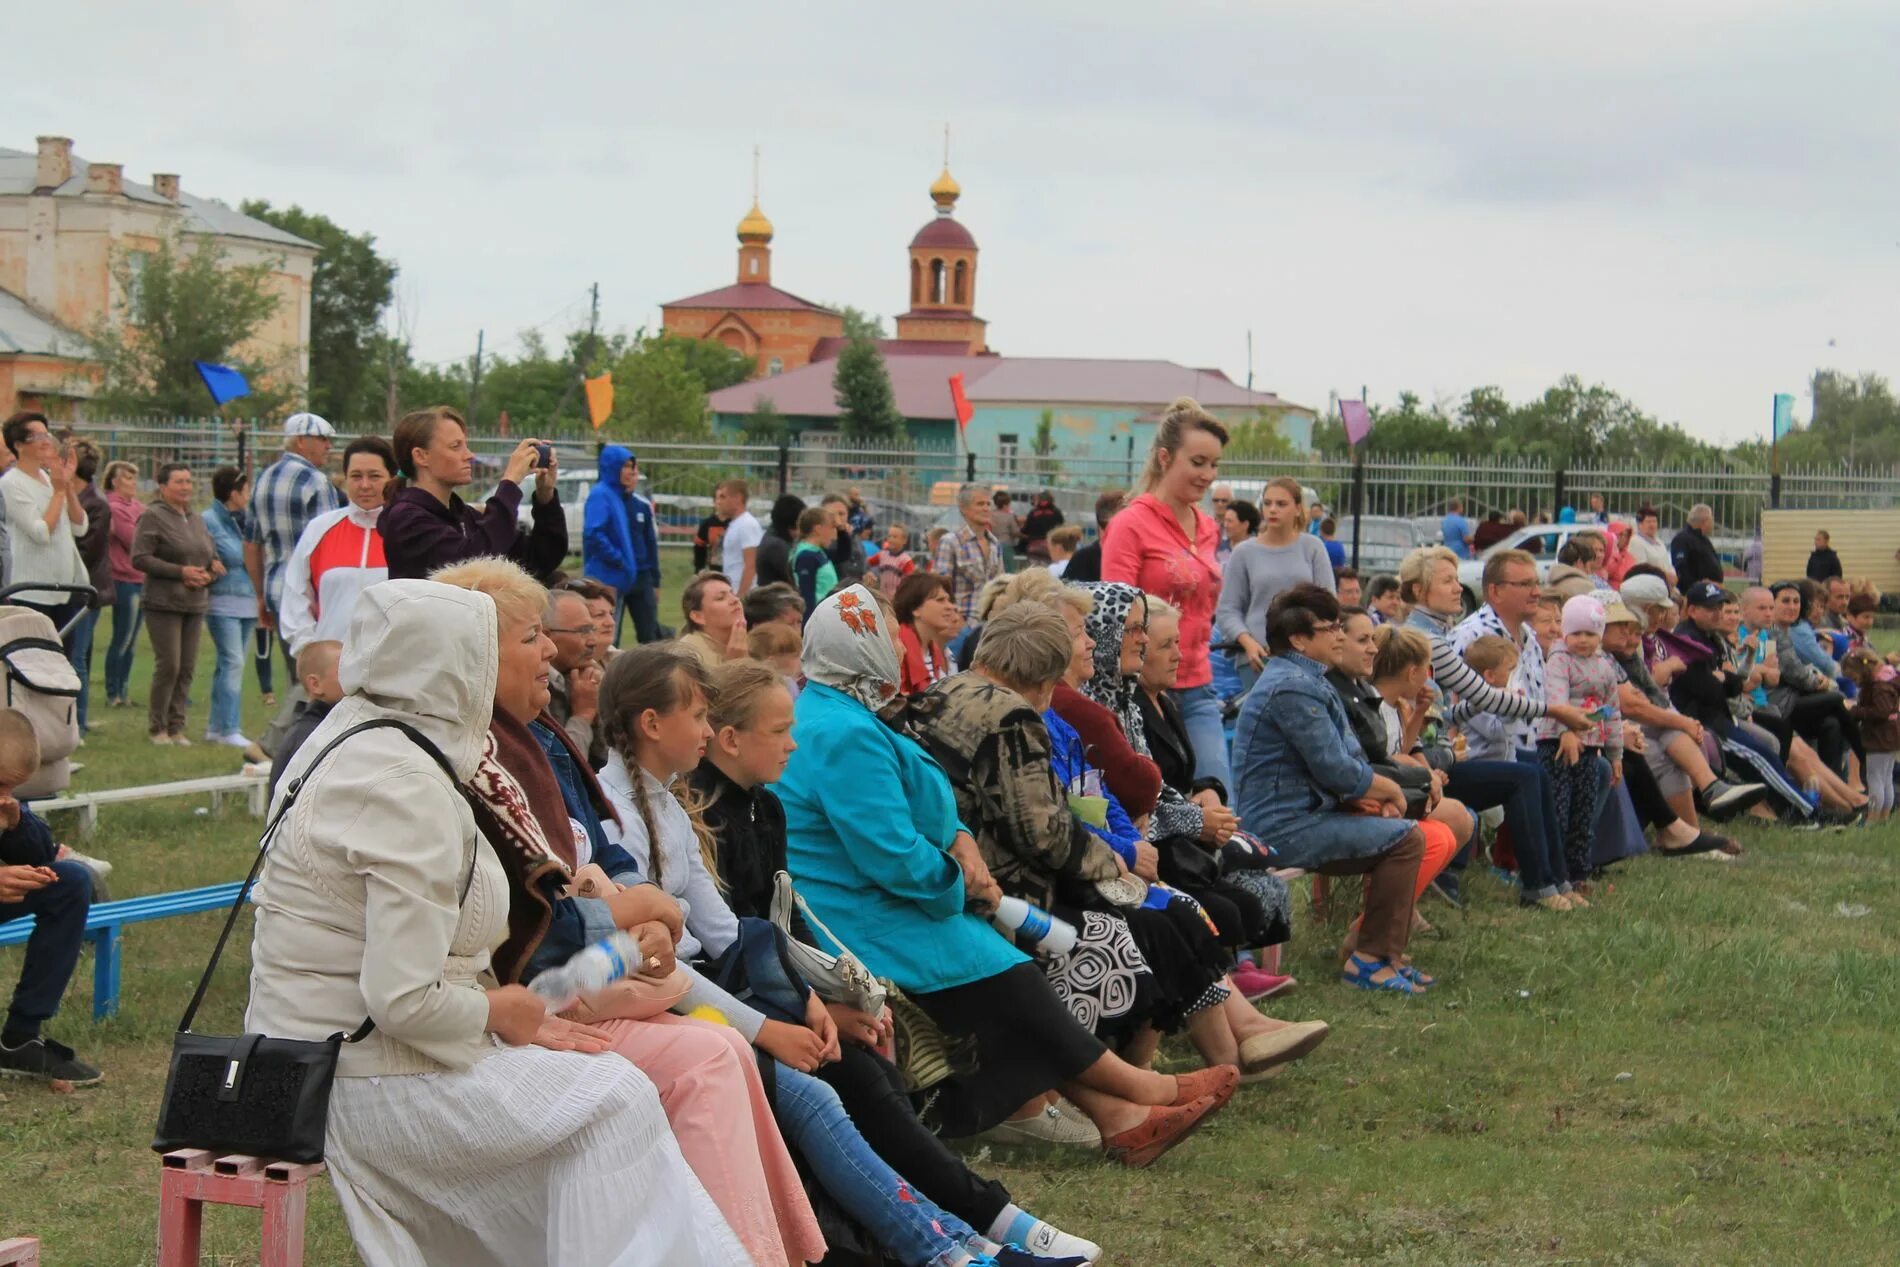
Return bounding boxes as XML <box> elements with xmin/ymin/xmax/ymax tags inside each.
<box><xmin>773</xmin><ymin>682</ymin><xmax>1028</xmax><ymax>993</ymax></box>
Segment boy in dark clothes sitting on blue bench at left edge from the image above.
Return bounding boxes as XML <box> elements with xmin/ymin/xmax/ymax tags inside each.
<box><xmin>0</xmin><ymin>709</ymin><xmax>103</xmax><ymax>1087</ymax></box>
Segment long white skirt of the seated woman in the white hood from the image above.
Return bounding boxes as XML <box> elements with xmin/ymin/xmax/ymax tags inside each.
<box><xmin>325</xmin><ymin>1045</ymin><xmax>749</xmax><ymax>1267</ymax></box>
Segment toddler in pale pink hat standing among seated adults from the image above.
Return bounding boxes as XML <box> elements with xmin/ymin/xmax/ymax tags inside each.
<box><xmin>1537</xmin><ymin>595</ymin><xmax>1623</xmax><ymax>885</ymax></box>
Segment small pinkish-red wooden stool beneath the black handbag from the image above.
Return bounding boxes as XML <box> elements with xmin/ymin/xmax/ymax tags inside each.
<box><xmin>157</xmin><ymin>1147</ymin><xmax>323</xmax><ymax>1267</ymax></box>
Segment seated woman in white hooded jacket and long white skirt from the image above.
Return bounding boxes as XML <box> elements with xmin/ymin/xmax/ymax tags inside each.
<box><xmin>245</xmin><ymin>581</ymin><xmax>745</xmax><ymax>1267</ymax></box>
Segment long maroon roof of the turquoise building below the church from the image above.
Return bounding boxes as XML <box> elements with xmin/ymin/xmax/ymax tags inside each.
<box><xmin>709</xmin><ymin>355</ymin><xmax>1300</xmax><ymax>418</ymax></box>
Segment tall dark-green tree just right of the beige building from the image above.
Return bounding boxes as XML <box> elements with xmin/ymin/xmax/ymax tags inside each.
<box><xmin>239</xmin><ymin>198</ymin><xmax>395</xmax><ymax>422</ymax></box>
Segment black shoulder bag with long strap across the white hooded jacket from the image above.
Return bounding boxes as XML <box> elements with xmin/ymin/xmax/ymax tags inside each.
<box><xmin>152</xmin><ymin>718</ymin><xmax>475</xmax><ymax>1163</ymax></box>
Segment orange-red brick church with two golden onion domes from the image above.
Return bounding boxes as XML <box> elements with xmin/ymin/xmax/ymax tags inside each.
<box><xmin>659</xmin><ymin>165</ymin><xmax>990</xmax><ymax>378</ymax></box>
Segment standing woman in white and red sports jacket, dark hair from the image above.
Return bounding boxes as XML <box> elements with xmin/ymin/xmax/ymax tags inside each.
<box><xmin>277</xmin><ymin>435</ymin><xmax>395</xmax><ymax>655</ymax></box>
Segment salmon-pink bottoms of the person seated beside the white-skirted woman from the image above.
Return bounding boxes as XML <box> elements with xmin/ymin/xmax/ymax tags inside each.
<box><xmin>599</xmin><ymin>1012</ymin><xmax>825</xmax><ymax>1267</ymax></box>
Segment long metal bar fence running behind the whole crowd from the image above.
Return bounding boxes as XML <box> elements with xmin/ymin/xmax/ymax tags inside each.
<box><xmin>55</xmin><ymin>418</ymin><xmax>1900</xmax><ymax>536</ymax></box>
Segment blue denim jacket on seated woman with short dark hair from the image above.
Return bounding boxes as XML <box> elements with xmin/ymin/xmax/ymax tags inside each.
<box><xmin>1233</xmin><ymin>652</ymin><xmax>1397</xmax><ymax>849</ymax></box>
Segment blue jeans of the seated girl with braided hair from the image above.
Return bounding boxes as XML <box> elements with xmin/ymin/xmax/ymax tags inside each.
<box><xmin>768</xmin><ymin>1064</ymin><xmax>977</xmax><ymax>1267</ymax></box>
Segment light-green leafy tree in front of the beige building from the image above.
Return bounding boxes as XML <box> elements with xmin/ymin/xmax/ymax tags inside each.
<box><xmin>84</xmin><ymin>236</ymin><xmax>300</xmax><ymax>416</ymax></box>
